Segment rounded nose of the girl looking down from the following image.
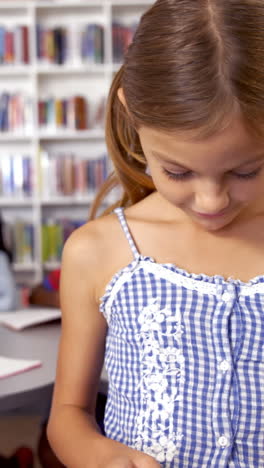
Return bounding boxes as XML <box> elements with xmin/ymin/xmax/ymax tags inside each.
<box><xmin>194</xmin><ymin>182</ymin><xmax>230</xmax><ymax>215</ymax></box>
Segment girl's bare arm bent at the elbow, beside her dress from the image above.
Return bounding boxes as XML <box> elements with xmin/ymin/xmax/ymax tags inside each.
<box><xmin>48</xmin><ymin>222</ymin><xmax>159</xmax><ymax>468</ymax></box>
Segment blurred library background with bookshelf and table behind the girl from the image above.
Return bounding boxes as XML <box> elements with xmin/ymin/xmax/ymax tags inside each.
<box><xmin>0</xmin><ymin>0</ymin><xmax>152</xmax><ymax>468</ymax></box>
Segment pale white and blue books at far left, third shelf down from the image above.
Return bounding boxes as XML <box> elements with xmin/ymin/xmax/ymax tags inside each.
<box><xmin>0</xmin><ymin>154</ymin><xmax>33</xmax><ymax>198</ymax></box>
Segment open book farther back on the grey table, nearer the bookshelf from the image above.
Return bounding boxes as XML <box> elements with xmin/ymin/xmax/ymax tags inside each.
<box><xmin>0</xmin><ymin>307</ymin><xmax>61</xmax><ymax>330</ymax></box>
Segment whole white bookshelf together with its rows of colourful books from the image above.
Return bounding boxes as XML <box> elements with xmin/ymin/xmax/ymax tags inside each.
<box><xmin>0</xmin><ymin>0</ymin><xmax>151</xmax><ymax>285</ymax></box>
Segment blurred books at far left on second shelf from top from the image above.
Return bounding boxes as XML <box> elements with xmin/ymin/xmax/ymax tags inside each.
<box><xmin>0</xmin><ymin>92</ymin><xmax>33</xmax><ymax>134</ymax></box>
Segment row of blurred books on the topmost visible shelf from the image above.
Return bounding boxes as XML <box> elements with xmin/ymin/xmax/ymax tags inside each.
<box><xmin>0</xmin><ymin>21</ymin><xmax>137</xmax><ymax>65</ymax></box>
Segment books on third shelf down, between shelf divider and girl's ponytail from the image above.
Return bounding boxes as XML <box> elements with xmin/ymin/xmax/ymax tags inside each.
<box><xmin>40</xmin><ymin>149</ymin><xmax>108</xmax><ymax>199</ymax></box>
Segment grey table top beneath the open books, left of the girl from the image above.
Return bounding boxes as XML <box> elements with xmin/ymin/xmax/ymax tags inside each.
<box><xmin>0</xmin><ymin>321</ymin><xmax>107</xmax><ymax>410</ymax></box>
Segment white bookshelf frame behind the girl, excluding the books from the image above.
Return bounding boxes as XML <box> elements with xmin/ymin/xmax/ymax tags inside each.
<box><xmin>0</xmin><ymin>0</ymin><xmax>154</xmax><ymax>285</ymax></box>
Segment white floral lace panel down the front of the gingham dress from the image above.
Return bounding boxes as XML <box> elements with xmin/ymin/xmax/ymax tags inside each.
<box><xmin>134</xmin><ymin>299</ymin><xmax>184</xmax><ymax>463</ymax></box>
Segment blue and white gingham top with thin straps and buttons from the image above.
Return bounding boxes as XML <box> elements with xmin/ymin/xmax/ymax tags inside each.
<box><xmin>100</xmin><ymin>209</ymin><xmax>264</xmax><ymax>468</ymax></box>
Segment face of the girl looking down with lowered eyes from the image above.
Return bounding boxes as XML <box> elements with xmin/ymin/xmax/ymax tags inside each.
<box><xmin>139</xmin><ymin>120</ymin><xmax>264</xmax><ymax>231</ymax></box>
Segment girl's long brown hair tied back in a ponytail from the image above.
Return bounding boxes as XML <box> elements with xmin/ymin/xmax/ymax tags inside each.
<box><xmin>91</xmin><ymin>0</ymin><xmax>264</xmax><ymax>218</ymax></box>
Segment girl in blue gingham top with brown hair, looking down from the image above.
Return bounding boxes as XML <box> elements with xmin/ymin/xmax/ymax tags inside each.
<box><xmin>49</xmin><ymin>0</ymin><xmax>264</xmax><ymax>468</ymax></box>
